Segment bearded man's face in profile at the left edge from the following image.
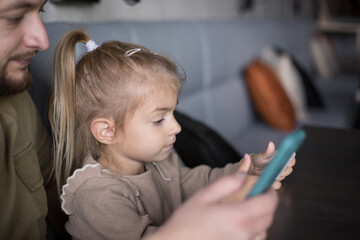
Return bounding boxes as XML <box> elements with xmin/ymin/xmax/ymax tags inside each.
<box><xmin>0</xmin><ymin>0</ymin><xmax>49</xmax><ymax>96</ymax></box>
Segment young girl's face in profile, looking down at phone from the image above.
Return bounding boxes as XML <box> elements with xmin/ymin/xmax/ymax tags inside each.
<box><xmin>115</xmin><ymin>87</ymin><xmax>181</xmax><ymax>166</ymax></box>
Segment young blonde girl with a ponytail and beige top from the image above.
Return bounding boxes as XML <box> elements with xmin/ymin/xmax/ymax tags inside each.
<box><xmin>50</xmin><ymin>31</ymin><xmax>292</xmax><ymax>240</ymax></box>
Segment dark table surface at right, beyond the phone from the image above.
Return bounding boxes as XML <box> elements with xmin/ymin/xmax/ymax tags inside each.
<box><xmin>267</xmin><ymin>126</ymin><xmax>360</xmax><ymax>240</ymax></box>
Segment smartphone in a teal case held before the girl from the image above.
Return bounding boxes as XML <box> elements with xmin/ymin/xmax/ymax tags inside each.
<box><xmin>247</xmin><ymin>129</ymin><xmax>306</xmax><ymax>198</ymax></box>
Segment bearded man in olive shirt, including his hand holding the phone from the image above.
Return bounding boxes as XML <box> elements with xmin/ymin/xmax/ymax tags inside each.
<box><xmin>0</xmin><ymin>0</ymin><xmax>277</xmax><ymax>240</ymax></box>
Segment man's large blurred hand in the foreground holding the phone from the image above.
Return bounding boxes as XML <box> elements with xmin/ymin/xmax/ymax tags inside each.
<box><xmin>146</xmin><ymin>173</ymin><xmax>278</xmax><ymax>240</ymax></box>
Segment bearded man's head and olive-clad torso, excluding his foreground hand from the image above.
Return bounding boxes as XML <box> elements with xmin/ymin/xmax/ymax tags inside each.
<box><xmin>0</xmin><ymin>0</ymin><xmax>64</xmax><ymax>239</ymax></box>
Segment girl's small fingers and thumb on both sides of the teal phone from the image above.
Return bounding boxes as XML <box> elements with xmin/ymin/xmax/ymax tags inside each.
<box><xmin>238</xmin><ymin>142</ymin><xmax>296</xmax><ymax>189</ymax></box>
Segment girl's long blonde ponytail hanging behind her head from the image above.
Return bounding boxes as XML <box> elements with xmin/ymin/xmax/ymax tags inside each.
<box><xmin>49</xmin><ymin>30</ymin><xmax>90</xmax><ymax>192</ymax></box>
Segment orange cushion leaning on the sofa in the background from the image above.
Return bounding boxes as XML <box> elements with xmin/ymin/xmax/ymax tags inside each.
<box><xmin>244</xmin><ymin>59</ymin><xmax>296</xmax><ymax>131</ymax></box>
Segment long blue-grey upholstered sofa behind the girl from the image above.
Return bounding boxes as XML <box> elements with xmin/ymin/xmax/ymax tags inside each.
<box><xmin>30</xmin><ymin>20</ymin><xmax>358</xmax><ymax>153</ymax></box>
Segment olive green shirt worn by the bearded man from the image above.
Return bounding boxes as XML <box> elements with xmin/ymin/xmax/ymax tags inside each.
<box><xmin>0</xmin><ymin>91</ymin><xmax>52</xmax><ymax>239</ymax></box>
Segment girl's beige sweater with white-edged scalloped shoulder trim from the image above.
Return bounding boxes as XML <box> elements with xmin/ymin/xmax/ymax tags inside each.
<box><xmin>61</xmin><ymin>153</ymin><xmax>238</xmax><ymax>240</ymax></box>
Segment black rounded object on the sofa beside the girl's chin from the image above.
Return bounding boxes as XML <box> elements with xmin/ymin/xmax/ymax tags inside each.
<box><xmin>174</xmin><ymin>111</ymin><xmax>241</xmax><ymax>167</ymax></box>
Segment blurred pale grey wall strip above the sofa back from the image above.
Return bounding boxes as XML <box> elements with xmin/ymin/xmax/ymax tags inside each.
<box><xmin>42</xmin><ymin>0</ymin><xmax>317</xmax><ymax>22</ymax></box>
